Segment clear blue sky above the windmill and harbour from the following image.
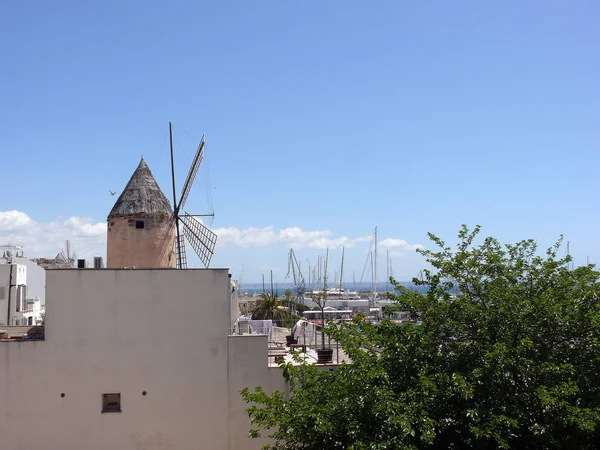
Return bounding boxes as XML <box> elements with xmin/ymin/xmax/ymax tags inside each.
<box><xmin>0</xmin><ymin>0</ymin><xmax>600</xmax><ymax>281</ymax></box>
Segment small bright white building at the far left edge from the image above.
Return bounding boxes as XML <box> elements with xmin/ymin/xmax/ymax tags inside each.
<box><xmin>0</xmin><ymin>246</ymin><xmax>46</xmax><ymax>326</ymax></box>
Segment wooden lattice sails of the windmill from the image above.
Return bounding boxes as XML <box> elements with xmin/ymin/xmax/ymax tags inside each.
<box><xmin>169</xmin><ymin>122</ymin><xmax>217</xmax><ymax>269</ymax></box>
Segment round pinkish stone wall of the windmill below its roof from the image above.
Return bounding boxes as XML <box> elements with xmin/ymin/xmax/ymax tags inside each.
<box><xmin>106</xmin><ymin>213</ymin><xmax>175</xmax><ymax>269</ymax></box>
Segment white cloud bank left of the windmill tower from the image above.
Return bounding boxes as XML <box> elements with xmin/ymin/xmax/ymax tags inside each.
<box><xmin>0</xmin><ymin>210</ymin><xmax>106</xmax><ymax>258</ymax></box>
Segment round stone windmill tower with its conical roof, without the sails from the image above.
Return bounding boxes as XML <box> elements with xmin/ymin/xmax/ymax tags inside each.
<box><xmin>106</xmin><ymin>158</ymin><xmax>176</xmax><ymax>269</ymax></box>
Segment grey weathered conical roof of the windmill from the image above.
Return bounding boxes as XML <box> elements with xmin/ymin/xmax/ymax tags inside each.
<box><xmin>108</xmin><ymin>158</ymin><xmax>173</xmax><ymax>217</ymax></box>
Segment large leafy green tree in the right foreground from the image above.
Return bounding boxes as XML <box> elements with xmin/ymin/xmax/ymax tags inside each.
<box><xmin>242</xmin><ymin>227</ymin><xmax>600</xmax><ymax>450</ymax></box>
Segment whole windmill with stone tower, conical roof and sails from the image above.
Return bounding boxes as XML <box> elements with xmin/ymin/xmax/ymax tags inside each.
<box><xmin>107</xmin><ymin>123</ymin><xmax>217</xmax><ymax>269</ymax></box>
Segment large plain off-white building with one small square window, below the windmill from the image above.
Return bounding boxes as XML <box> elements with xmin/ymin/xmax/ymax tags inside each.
<box><xmin>0</xmin><ymin>269</ymin><xmax>285</xmax><ymax>450</ymax></box>
